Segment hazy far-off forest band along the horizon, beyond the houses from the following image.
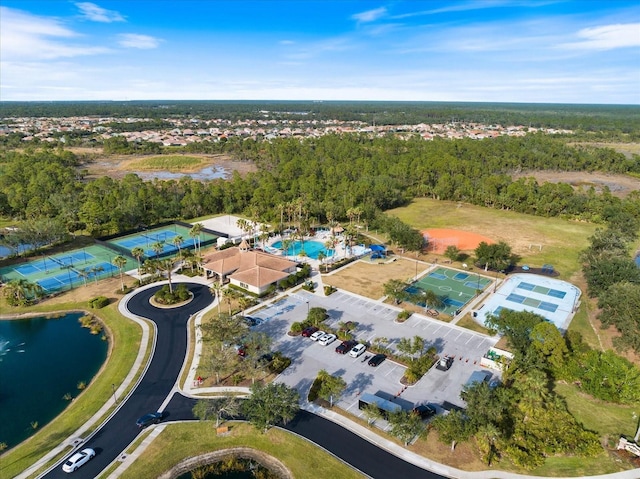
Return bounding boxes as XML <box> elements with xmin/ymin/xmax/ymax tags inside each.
<box><xmin>0</xmin><ymin>100</ymin><xmax>640</xmax><ymax>139</ymax></box>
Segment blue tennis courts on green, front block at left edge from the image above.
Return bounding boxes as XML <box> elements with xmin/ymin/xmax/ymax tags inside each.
<box><xmin>0</xmin><ymin>245</ymin><xmax>137</xmax><ymax>293</ymax></box>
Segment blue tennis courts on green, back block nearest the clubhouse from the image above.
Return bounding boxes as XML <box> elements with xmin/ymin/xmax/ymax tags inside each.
<box><xmin>106</xmin><ymin>224</ymin><xmax>218</xmax><ymax>261</ymax></box>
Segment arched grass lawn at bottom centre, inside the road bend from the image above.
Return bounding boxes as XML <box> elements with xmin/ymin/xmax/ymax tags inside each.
<box><xmin>120</xmin><ymin>422</ymin><xmax>363</xmax><ymax>479</ymax></box>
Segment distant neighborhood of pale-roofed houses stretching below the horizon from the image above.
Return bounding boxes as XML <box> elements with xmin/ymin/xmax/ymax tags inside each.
<box><xmin>0</xmin><ymin>111</ymin><xmax>573</xmax><ymax>146</ymax></box>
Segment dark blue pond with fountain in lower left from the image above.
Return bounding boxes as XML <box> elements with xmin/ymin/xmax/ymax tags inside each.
<box><xmin>0</xmin><ymin>313</ymin><xmax>109</xmax><ymax>448</ymax></box>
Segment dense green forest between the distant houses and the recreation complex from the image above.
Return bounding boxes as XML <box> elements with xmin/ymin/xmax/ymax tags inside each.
<box><xmin>0</xmin><ymin>134</ymin><xmax>640</xmax><ymax>236</ymax></box>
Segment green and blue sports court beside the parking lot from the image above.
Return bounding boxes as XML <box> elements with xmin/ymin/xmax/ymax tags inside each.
<box><xmin>406</xmin><ymin>267</ymin><xmax>491</xmax><ymax>316</ymax></box>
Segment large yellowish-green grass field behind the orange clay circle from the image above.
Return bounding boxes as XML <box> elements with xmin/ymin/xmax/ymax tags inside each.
<box><xmin>387</xmin><ymin>198</ymin><xmax>596</xmax><ymax>279</ymax></box>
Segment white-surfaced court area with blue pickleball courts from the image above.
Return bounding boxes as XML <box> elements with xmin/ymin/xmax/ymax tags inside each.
<box><xmin>474</xmin><ymin>273</ymin><xmax>581</xmax><ymax>332</ymax></box>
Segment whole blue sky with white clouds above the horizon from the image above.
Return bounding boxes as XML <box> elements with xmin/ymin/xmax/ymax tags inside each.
<box><xmin>0</xmin><ymin>0</ymin><xmax>640</xmax><ymax>104</ymax></box>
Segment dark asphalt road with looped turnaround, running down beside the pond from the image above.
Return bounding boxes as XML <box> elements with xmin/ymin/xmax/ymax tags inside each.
<box><xmin>43</xmin><ymin>283</ymin><xmax>213</xmax><ymax>478</ymax></box>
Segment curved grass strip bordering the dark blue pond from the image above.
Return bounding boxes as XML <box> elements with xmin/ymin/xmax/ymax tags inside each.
<box><xmin>0</xmin><ymin>303</ymin><xmax>142</xmax><ymax>478</ymax></box>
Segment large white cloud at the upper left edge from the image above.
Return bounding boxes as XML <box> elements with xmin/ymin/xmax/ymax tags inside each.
<box><xmin>0</xmin><ymin>7</ymin><xmax>109</xmax><ymax>61</ymax></box>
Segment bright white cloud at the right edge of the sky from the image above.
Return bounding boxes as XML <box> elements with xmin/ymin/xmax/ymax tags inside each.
<box><xmin>560</xmin><ymin>23</ymin><xmax>640</xmax><ymax>50</ymax></box>
